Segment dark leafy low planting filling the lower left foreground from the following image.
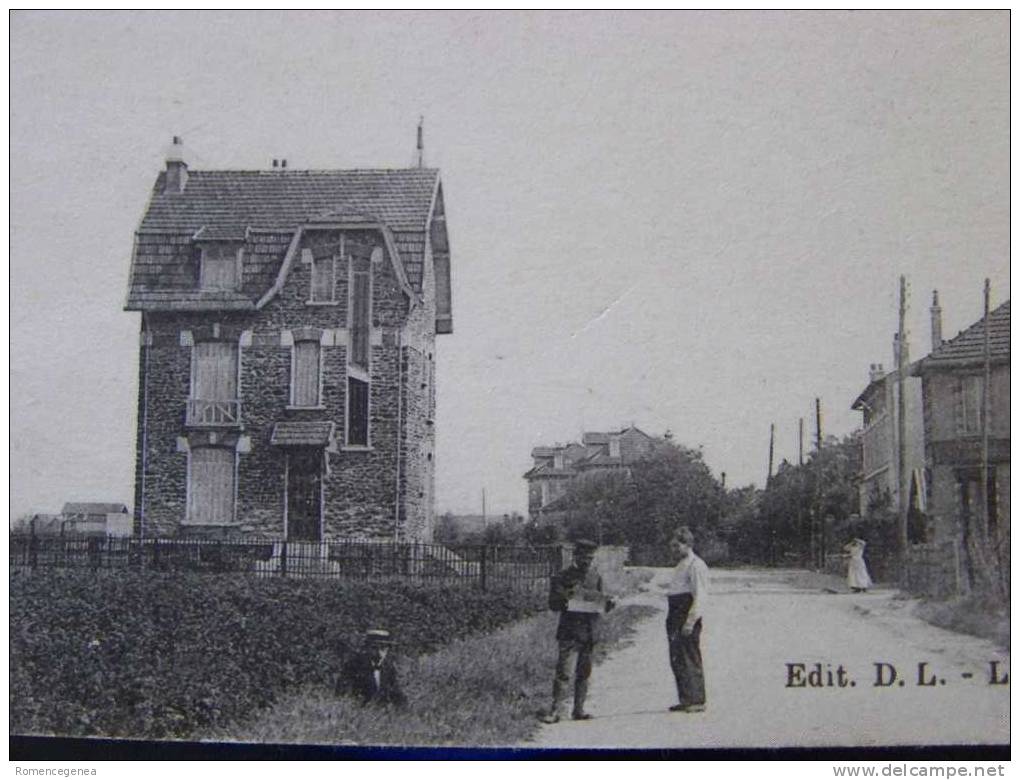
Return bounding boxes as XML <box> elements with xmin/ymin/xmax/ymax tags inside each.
<box><xmin>10</xmin><ymin>571</ymin><xmax>545</xmax><ymax>738</ymax></box>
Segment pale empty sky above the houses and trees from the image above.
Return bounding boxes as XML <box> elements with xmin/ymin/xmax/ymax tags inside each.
<box><xmin>10</xmin><ymin>11</ymin><xmax>1010</xmax><ymax>516</ymax></box>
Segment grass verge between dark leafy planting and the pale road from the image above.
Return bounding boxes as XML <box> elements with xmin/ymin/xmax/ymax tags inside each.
<box><xmin>197</xmin><ymin>605</ymin><xmax>656</xmax><ymax>745</ymax></box>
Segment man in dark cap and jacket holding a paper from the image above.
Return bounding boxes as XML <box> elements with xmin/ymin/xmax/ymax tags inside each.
<box><xmin>542</xmin><ymin>539</ymin><xmax>613</xmax><ymax>723</ymax></box>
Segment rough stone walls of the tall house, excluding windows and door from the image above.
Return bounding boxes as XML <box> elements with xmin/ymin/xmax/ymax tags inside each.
<box><xmin>135</xmin><ymin>231</ymin><xmax>435</xmax><ymax>538</ymax></box>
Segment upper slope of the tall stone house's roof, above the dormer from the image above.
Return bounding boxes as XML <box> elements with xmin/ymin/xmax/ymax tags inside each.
<box><xmin>139</xmin><ymin>168</ymin><xmax>439</xmax><ymax>235</ymax></box>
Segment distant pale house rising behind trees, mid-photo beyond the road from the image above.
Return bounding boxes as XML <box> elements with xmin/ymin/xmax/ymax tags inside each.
<box><xmin>524</xmin><ymin>425</ymin><xmax>655</xmax><ymax>520</ymax></box>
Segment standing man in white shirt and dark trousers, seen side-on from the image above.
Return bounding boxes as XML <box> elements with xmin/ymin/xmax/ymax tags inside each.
<box><xmin>666</xmin><ymin>526</ymin><xmax>708</xmax><ymax>713</ymax></box>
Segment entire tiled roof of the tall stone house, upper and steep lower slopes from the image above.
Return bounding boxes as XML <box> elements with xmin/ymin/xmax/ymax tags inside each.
<box><xmin>126</xmin><ymin>168</ymin><xmax>439</xmax><ymax>311</ymax></box>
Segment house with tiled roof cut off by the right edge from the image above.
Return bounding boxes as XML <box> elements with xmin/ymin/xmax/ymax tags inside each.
<box><xmin>913</xmin><ymin>301</ymin><xmax>1010</xmax><ymax>584</ymax></box>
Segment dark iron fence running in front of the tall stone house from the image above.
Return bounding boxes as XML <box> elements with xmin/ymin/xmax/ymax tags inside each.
<box><xmin>10</xmin><ymin>533</ymin><xmax>563</xmax><ymax>589</ymax></box>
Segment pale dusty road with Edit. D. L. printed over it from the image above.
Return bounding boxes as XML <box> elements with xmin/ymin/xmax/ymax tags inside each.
<box><xmin>529</xmin><ymin>570</ymin><xmax>1009</xmax><ymax>747</ymax></box>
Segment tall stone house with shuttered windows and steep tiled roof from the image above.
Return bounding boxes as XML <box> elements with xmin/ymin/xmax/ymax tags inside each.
<box><xmin>126</xmin><ymin>139</ymin><xmax>453</xmax><ymax>541</ymax></box>
